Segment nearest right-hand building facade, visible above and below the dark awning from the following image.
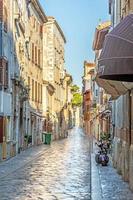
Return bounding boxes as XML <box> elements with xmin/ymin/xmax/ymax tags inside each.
<box><xmin>110</xmin><ymin>0</ymin><xmax>133</xmax><ymax>189</ymax></box>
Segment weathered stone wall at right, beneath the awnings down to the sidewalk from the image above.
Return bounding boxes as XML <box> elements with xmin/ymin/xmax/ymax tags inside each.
<box><xmin>113</xmin><ymin>93</ymin><xmax>130</xmax><ymax>181</ymax></box>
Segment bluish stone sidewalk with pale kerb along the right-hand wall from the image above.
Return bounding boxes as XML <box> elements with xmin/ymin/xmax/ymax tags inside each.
<box><xmin>91</xmin><ymin>141</ymin><xmax>133</xmax><ymax>200</ymax></box>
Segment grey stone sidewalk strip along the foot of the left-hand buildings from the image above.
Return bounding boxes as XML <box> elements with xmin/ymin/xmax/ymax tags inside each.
<box><xmin>0</xmin><ymin>144</ymin><xmax>50</xmax><ymax>179</ymax></box>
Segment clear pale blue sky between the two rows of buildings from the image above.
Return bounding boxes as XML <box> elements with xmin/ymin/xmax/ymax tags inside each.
<box><xmin>40</xmin><ymin>0</ymin><xmax>109</xmax><ymax>86</ymax></box>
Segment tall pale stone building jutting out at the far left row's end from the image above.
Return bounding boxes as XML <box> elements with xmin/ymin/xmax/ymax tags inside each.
<box><xmin>44</xmin><ymin>17</ymin><xmax>66</xmax><ymax>139</ymax></box>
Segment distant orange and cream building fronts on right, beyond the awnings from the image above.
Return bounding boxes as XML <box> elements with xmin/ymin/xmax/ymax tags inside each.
<box><xmin>83</xmin><ymin>57</ymin><xmax>111</xmax><ymax>140</ymax></box>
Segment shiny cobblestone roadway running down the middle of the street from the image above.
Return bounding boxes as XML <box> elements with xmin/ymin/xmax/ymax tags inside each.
<box><xmin>0</xmin><ymin>129</ymin><xmax>91</xmax><ymax>200</ymax></box>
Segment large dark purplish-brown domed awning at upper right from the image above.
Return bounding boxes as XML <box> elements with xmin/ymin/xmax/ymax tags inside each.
<box><xmin>98</xmin><ymin>14</ymin><xmax>133</xmax><ymax>82</ymax></box>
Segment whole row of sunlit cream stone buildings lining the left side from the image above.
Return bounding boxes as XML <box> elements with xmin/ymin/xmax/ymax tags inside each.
<box><xmin>0</xmin><ymin>0</ymin><xmax>72</xmax><ymax>160</ymax></box>
